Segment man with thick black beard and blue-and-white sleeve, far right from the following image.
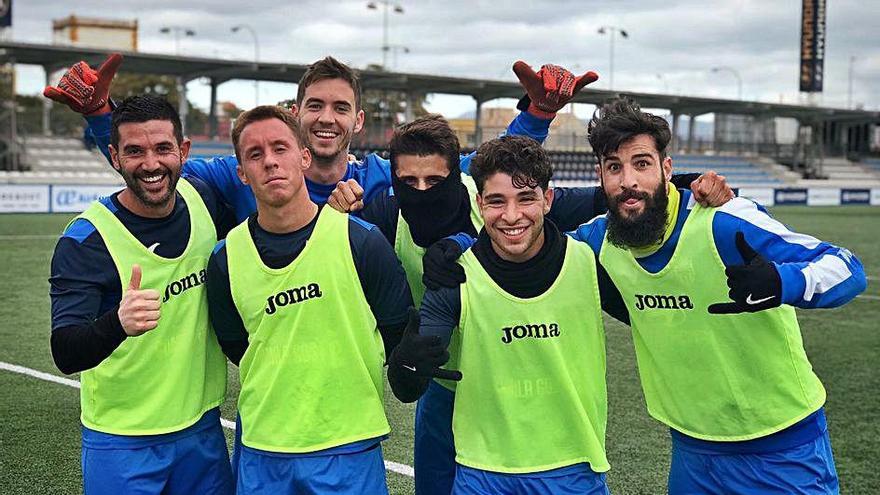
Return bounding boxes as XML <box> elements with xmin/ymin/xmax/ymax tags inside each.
<box><xmin>575</xmin><ymin>99</ymin><xmax>866</xmax><ymax>494</ymax></box>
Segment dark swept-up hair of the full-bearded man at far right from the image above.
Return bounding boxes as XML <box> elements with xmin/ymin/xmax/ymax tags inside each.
<box><xmin>587</xmin><ymin>98</ymin><xmax>672</xmax><ymax>163</ymax></box>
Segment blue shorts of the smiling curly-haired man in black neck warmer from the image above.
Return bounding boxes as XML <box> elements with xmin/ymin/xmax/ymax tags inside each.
<box><xmin>452</xmin><ymin>464</ymin><xmax>611</xmax><ymax>495</ymax></box>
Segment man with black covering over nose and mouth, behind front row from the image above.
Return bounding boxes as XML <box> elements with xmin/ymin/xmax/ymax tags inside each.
<box><xmin>350</xmin><ymin>112</ymin><xmax>732</xmax><ymax>495</ymax></box>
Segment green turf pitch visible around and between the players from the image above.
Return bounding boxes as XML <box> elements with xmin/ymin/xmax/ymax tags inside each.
<box><xmin>0</xmin><ymin>206</ymin><xmax>880</xmax><ymax>494</ymax></box>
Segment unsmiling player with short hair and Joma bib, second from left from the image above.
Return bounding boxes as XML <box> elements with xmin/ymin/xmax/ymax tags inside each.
<box><xmin>207</xmin><ymin>106</ymin><xmax>412</xmax><ymax>494</ymax></box>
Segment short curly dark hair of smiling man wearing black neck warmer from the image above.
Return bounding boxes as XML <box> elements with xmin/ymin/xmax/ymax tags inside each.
<box><xmin>470</xmin><ymin>136</ymin><xmax>553</xmax><ymax>194</ymax></box>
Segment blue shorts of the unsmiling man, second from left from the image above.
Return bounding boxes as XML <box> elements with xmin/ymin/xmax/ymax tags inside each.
<box><xmin>236</xmin><ymin>441</ymin><xmax>388</xmax><ymax>495</ymax></box>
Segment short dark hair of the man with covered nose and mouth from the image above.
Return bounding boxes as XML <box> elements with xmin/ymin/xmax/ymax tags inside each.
<box><xmin>388</xmin><ymin>113</ymin><xmax>461</xmax><ymax>173</ymax></box>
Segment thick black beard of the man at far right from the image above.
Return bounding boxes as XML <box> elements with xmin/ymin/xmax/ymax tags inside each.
<box><xmin>607</xmin><ymin>179</ymin><xmax>669</xmax><ymax>249</ymax></box>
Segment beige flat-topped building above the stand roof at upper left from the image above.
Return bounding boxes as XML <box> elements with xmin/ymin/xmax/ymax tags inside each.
<box><xmin>52</xmin><ymin>14</ymin><xmax>138</xmax><ymax>52</ymax></box>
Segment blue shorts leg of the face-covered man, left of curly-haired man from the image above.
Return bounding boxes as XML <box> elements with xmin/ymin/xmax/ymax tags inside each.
<box><xmin>413</xmin><ymin>380</ymin><xmax>455</xmax><ymax>495</ymax></box>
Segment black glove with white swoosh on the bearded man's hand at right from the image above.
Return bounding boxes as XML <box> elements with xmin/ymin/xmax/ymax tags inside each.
<box><xmin>709</xmin><ymin>232</ymin><xmax>782</xmax><ymax>314</ymax></box>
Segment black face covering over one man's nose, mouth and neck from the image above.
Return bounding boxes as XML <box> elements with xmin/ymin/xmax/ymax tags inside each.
<box><xmin>391</xmin><ymin>171</ymin><xmax>477</xmax><ymax>247</ymax></box>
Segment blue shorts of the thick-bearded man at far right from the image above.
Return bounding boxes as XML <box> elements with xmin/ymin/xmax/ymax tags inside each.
<box><xmin>669</xmin><ymin>414</ymin><xmax>840</xmax><ymax>495</ymax></box>
